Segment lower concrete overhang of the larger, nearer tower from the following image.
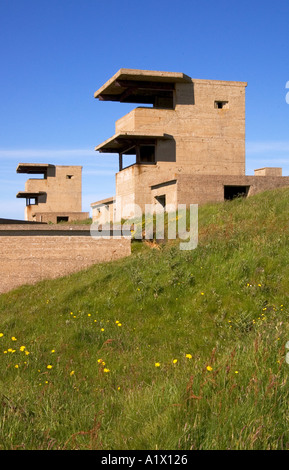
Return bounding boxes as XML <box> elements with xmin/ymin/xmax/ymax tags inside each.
<box><xmin>95</xmin><ymin>132</ymin><xmax>173</xmax><ymax>153</ymax></box>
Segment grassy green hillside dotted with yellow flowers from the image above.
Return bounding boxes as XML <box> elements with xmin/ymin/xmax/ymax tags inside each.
<box><xmin>0</xmin><ymin>185</ymin><xmax>289</xmax><ymax>450</ymax></box>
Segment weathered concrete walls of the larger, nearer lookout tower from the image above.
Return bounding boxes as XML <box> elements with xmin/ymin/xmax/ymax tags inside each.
<box><xmin>115</xmin><ymin>79</ymin><xmax>246</xmax><ymax>217</ymax></box>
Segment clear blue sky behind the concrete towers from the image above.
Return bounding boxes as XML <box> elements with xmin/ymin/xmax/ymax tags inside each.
<box><xmin>0</xmin><ymin>0</ymin><xmax>289</xmax><ymax>218</ymax></box>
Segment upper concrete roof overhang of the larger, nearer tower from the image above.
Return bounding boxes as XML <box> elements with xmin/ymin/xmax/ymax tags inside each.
<box><xmin>94</xmin><ymin>69</ymin><xmax>191</xmax><ymax>104</ymax></box>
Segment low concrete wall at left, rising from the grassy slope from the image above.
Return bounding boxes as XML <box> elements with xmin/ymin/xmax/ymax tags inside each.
<box><xmin>0</xmin><ymin>224</ymin><xmax>131</xmax><ymax>294</ymax></box>
